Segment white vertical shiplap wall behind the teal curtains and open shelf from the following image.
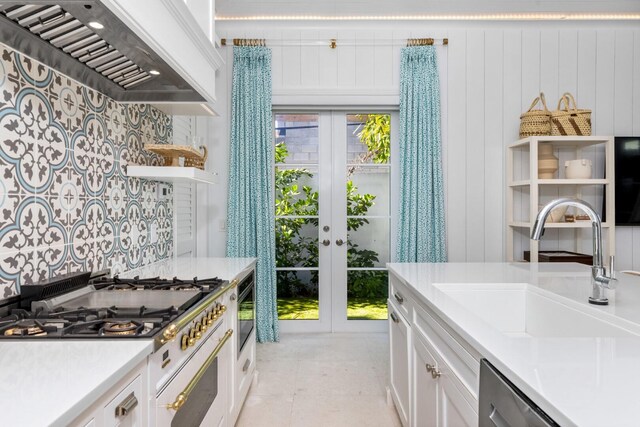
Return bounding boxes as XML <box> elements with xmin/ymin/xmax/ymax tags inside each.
<box><xmin>209</xmin><ymin>21</ymin><xmax>640</xmax><ymax>270</ymax></box>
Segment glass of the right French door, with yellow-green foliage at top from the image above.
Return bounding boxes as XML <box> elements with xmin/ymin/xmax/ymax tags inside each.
<box><xmin>343</xmin><ymin>114</ymin><xmax>391</xmax><ymax>320</ymax></box>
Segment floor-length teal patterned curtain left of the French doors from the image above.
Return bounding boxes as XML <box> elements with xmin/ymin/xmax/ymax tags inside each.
<box><xmin>227</xmin><ymin>47</ymin><xmax>278</xmax><ymax>342</ymax></box>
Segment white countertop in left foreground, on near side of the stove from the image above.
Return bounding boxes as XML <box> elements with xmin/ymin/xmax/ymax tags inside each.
<box><xmin>0</xmin><ymin>340</ymin><xmax>153</xmax><ymax>427</ymax></box>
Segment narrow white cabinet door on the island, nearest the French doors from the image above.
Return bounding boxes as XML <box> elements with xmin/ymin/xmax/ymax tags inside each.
<box><xmin>388</xmin><ymin>300</ymin><xmax>411</xmax><ymax>426</ymax></box>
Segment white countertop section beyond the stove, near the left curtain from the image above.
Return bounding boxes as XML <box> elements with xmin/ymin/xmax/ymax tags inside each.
<box><xmin>120</xmin><ymin>257</ymin><xmax>256</xmax><ymax>280</ymax></box>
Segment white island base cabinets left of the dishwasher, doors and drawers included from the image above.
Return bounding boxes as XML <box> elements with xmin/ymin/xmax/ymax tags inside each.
<box><xmin>388</xmin><ymin>272</ymin><xmax>480</xmax><ymax>427</ymax></box>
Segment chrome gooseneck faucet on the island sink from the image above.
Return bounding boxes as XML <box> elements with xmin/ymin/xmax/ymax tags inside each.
<box><xmin>531</xmin><ymin>198</ymin><xmax>616</xmax><ymax>305</ymax></box>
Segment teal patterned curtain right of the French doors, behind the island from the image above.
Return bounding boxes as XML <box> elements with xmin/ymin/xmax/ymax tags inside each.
<box><xmin>396</xmin><ymin>46</ymin><xmax>447</xmax><ymax>262</ymax></box>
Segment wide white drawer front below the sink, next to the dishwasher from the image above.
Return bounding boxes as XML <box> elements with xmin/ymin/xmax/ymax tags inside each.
<box><xmin>412</xmin><ymin>307</ymin><xmax>480</xmax><ymax>400</ymax></box>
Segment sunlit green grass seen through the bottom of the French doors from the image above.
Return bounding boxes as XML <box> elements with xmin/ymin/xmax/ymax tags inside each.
<box><xmin>278</xmin><ymin>297</ymin><xmax>387</xmax><ymax>320</ymax></box>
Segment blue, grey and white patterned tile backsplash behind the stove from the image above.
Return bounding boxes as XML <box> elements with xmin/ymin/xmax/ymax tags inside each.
<box><xmin>0</xmin><ymin>44</ymin><xmax>173</xmax><ymax>299</ymax></box>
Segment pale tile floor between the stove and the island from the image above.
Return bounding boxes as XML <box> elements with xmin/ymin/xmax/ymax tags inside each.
<box><xmin>236</xmin><ymin>333</ymin><xmax>400</xmax><ymax>427</ymax></box>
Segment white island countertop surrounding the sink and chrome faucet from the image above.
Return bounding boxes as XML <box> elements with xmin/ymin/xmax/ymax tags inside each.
<box><xmin>388</xmin><ymin>263</ymin><xmax>640</xmax><ymax>427</ymax></box>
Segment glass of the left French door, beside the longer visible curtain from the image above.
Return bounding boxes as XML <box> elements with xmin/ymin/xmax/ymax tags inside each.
<box><xmin>274</xmin><ymin>114</ymin><xmax>320</xmax><ymax>320</ymax></box>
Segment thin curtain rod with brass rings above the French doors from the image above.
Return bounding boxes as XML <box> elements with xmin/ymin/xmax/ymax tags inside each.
<box><xmin>220</xmin><ymin>38</ymin><xmax>449</xmax><ymax>49</ymax></box>
